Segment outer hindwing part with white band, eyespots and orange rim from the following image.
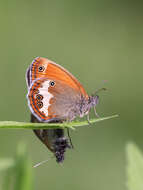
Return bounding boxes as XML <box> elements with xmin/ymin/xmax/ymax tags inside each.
<box><xmin>27</xmin><ymin>78</ymin><xmax>53</xmax><ymax>121</ymax></box>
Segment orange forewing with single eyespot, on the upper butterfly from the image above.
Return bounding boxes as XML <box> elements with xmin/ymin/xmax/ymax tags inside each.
<box><xmin>27</xmin><ymin>57</ymin><xmax>88</xmax><ymax>97</ymax></box>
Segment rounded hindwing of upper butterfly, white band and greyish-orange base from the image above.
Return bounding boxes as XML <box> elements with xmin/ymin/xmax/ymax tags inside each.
<box><xmin>27</xmin><ymin>78</ymin><xmax>82</xmax><ymax>122</ymax></box>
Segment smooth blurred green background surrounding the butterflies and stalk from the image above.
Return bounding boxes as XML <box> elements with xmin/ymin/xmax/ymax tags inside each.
<box><xmin>0</xmin><ymin>0</ymin><xmax>143</xmax><ymax>190</ymax></box>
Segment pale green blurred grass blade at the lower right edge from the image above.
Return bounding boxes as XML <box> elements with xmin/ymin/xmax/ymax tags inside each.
<box><xmin>127</xmin><ymin>143</ymin><xmax>143</xmax><ymax>190</ymax></box>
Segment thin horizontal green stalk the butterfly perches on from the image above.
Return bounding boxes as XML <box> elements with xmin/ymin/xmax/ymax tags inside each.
<box><xmin>0</xmin><ymin>115</ymin><xmax>118</xmax><ymax>129</ymax></box>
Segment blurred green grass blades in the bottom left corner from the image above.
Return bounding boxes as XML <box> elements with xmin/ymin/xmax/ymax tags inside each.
<box><xmin>0</xmin><ymin>144</ymin><xmax>33</xmax><ymax>190</ymax></box>
